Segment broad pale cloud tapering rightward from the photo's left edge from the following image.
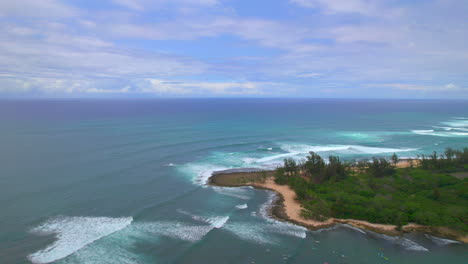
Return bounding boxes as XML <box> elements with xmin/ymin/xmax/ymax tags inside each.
<box><xmin>0</xmin><ymin>23</ymin><xmax>206</xmax><ymax>79</ymax></box>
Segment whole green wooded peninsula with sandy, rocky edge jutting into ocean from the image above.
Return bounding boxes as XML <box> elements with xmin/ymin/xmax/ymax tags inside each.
<box><xmin>209</xmin><ymin>148</ymin><xmax>468</xmax><ymax>243</ymax></box>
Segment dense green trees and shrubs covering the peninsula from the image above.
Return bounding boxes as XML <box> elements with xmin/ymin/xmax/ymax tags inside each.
<box><xmin>274</xmin><ymin>148</ymin><xmax>468</xmax><ymax>234</ymax></box>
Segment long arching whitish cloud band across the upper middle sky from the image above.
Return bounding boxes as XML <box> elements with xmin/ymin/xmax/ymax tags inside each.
<box><xmin>108</xmin><ymin>17</ymin><xmax>321</xmax><ymax>52</ymax></box>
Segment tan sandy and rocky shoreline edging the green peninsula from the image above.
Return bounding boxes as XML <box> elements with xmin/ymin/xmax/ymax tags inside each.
<box><xmin>208</xmin><ymin>159</ymin><xmax>468</xmax><ymax>243</ymax></box>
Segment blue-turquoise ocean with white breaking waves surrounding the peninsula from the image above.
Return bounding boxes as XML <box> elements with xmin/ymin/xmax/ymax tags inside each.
<box><xmin>0</xmin><ymin>99</ymin><xmax>468</xmax><ymax>264</ymax></box>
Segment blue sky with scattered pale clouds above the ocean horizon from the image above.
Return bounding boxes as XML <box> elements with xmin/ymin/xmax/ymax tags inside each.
<box><xmin>0</xmin><ymin>0</ymin><xmax>468</xmax><ymax>99</ymax></box>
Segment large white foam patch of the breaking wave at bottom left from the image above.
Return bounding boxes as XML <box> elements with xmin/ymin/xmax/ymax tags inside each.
<box><xmin>28</xmin><ymin>217</ymin><xmax>133</xmax><ymax>263</ymax></box>
